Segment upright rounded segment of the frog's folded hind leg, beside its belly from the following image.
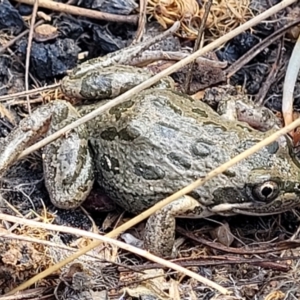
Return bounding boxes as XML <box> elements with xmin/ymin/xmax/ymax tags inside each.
<box><xmin>43</xmin><ymin>101</ymin><xmax>94</xmax><ymax>209</ymax></box>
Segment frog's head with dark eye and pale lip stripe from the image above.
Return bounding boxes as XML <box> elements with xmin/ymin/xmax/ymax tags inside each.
<box><xmin>212</xmin><ymin>135</ymin><xmax>300</xmax><ymax>216</ymax></box>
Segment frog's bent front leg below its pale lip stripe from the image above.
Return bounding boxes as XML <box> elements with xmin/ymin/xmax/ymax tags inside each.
<box><xmin>144</xmin><ymin>196</ymin><xmax>212</xmax><ymax>257</ymax></box>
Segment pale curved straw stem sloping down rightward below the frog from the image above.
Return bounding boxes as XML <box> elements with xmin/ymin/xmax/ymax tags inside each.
<box><xmin>0</xmin><ymin>214</ymin><xmax>229</xmax><ymax>295</ymax></box>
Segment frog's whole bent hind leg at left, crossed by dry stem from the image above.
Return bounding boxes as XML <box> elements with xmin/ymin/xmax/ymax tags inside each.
<box><xmin>0</xmin><ymin>100</ymin><xmax>94</xmax><ymax>209</ymax></box>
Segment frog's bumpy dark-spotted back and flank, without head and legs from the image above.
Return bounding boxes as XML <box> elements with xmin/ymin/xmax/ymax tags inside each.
<box><xmin>85</xmin><ymin>89</ymin><xmax>294</xmax><ymax>213</ymax></box>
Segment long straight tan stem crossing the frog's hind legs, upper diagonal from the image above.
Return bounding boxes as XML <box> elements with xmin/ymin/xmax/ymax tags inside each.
<box><xmin>19</xmin><ymin>0</ymin><xmax>296</xmax><ymax>159</ymax></box>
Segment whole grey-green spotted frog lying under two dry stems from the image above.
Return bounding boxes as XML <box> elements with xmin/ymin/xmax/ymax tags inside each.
<box><xmin>0</xmin><ymin>64</ymin><xmax>300</xmax><ymax>257</ymax></box>
